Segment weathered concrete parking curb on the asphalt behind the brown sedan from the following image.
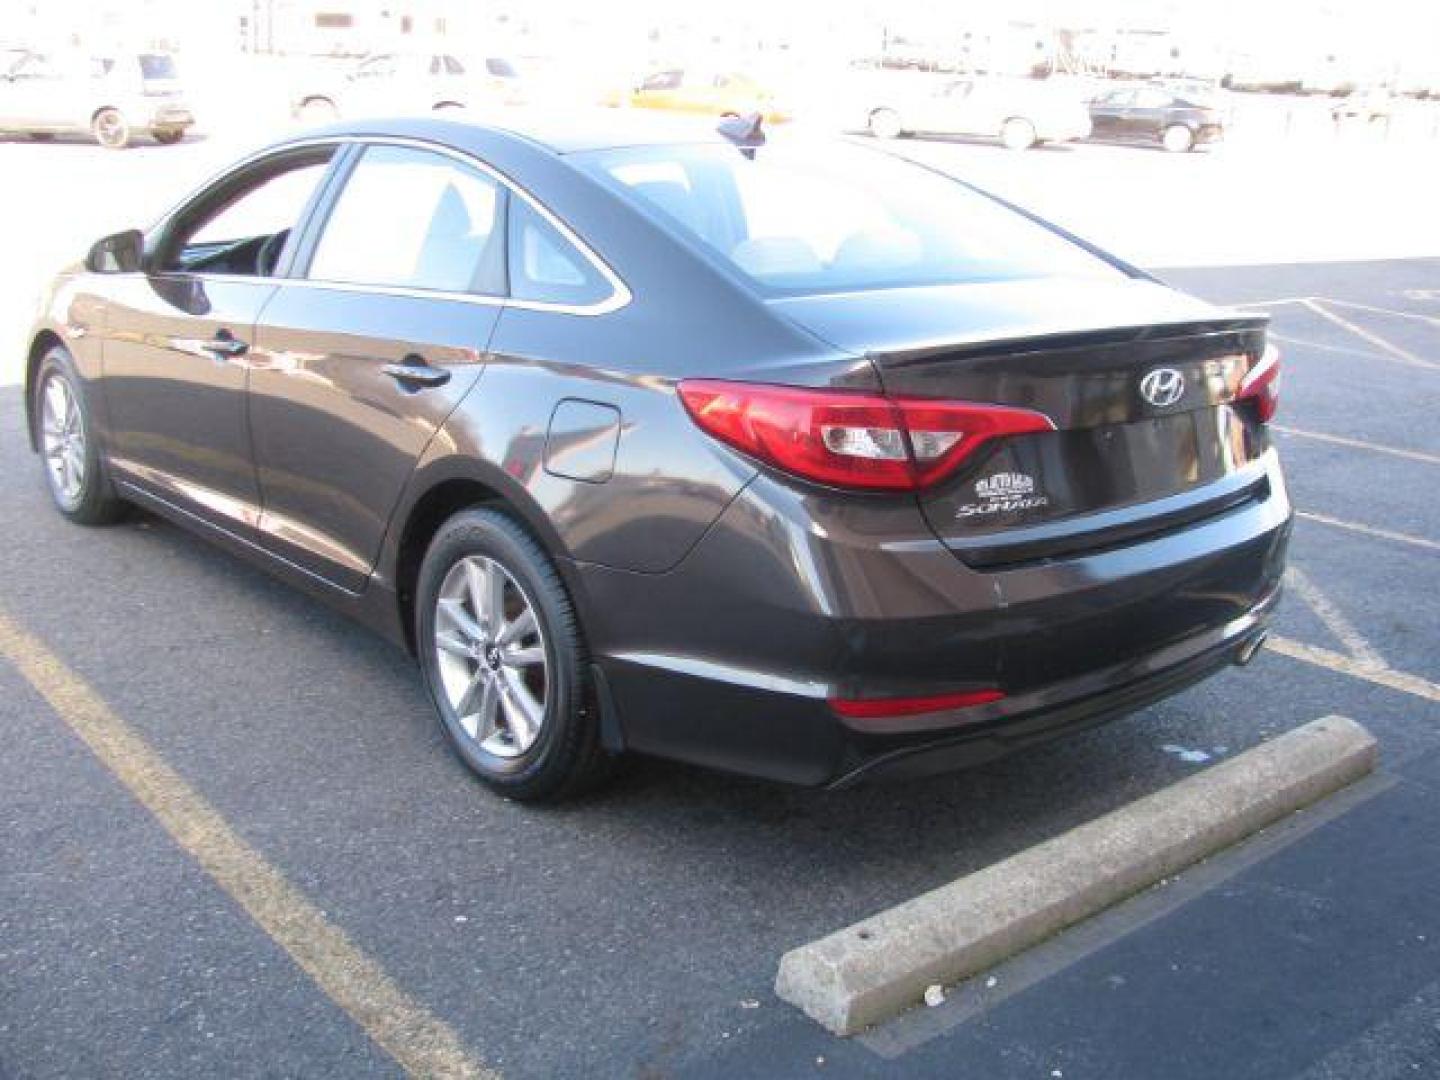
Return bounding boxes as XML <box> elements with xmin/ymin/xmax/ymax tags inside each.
<box><xmin>775</xmin><ymin>716</ymin><xmax>1377</xmax><ymax>1035</ymax></box>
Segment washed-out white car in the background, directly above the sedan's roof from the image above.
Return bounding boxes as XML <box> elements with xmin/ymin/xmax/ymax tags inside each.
<box><xmin>291</xmin><ymin>52</ymin><xmax>526</xmax><ymax>124</ymax></box>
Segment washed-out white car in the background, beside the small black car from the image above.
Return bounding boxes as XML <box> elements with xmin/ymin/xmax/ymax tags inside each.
<box><xmin>861</xmin><ymin>72</ymin><xmax>1090</xmax><ymax>150</ymax></box>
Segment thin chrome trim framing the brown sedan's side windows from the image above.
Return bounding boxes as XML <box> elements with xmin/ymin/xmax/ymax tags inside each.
<box><xmin>137</xmin><ymin>135</ymin><xmax>634</xmax><ymax>317</ymax></box>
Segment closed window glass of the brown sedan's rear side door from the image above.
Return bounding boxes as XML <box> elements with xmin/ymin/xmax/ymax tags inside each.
<box><xmin>307</xmin><ymin>147</ymin><xmax>505</xmax><ymax>295</ymax></box>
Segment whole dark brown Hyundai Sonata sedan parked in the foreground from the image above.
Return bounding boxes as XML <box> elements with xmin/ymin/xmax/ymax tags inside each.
<box><xmin>26</xmin><ymin>118</ymin><xmax>1290</xmax><ymax>798</ymax></box>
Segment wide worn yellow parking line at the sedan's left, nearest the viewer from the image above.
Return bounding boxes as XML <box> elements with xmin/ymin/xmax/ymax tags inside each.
<box><xmin>0</xmin><ymin>611</ymin><xmax>497</xmax><ymax>1077</ymax></box>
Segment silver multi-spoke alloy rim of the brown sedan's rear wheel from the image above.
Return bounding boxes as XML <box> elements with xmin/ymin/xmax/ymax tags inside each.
<box><xmin>433</xmin><ymin>556</ymin><xmax>550</xmax><ymax>757</ymax></box>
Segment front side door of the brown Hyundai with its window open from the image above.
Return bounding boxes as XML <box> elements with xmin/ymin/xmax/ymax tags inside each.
<box><xmin>102</xmin><ymin>148</ymin><xmax>333</xmax><ymax>537</ymax></box>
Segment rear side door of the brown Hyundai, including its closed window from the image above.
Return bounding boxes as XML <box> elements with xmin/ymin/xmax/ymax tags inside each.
<box><xmin>249</xmin><ymin>143</ymin><xmax>507</xmax><ymax>590</ymax></box>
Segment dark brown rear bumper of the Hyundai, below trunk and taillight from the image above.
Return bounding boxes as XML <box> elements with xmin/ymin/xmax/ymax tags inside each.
<box><xmin>573</xmin><ymin>455</ymin><xmax>1290</xmax><ymax>786</ymax></box>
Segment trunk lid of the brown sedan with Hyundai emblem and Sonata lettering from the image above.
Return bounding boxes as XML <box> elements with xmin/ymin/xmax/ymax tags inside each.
<box><xmin>773</xmin><ymin>278</ymin><xmax>1267</xmax><ymax>567</ymax></box>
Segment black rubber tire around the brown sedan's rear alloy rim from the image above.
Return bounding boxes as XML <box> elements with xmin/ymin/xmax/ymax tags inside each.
<box><xmin>415</xmin><ymin>508</ymin><xmax>612</xmax><ymax>802</ymax></box>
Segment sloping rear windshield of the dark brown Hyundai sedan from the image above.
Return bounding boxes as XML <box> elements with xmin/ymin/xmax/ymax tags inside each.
<box><xmin>576</xmin><ymin>140</ymin><xmax>1122</xmax><ymax>295</ymax></box>
